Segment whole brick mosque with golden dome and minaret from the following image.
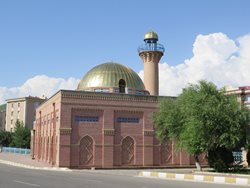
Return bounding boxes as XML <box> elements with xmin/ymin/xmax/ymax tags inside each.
<box><xmin>31</xmin><ymin>31</ymin><xmax>204</xmax><ymax>168</ymax></box>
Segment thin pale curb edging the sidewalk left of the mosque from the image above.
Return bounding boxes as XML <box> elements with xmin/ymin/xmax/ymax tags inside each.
<box><xmin>0</xmin><ymin>159</ymin><xmax>72</xmax><ymax>172</ymax></box>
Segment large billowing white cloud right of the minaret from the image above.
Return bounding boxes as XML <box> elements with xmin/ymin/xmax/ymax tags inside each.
<box><xmin>139</xmin><ymin>33</ymin><xmax>250</xmax><ymax>96</ymax></box>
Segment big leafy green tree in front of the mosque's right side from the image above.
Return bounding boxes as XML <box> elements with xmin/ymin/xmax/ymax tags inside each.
<box><xmin>153</xmin><ymin>81</ymin><xmax>249</xmax><ymax>170</ymax></box>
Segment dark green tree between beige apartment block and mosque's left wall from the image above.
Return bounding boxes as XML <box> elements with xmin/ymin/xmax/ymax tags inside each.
<box><xmin>11</xmin><ymin>120</ymin><xmax>31</xmax><ymax>148</ymax></box>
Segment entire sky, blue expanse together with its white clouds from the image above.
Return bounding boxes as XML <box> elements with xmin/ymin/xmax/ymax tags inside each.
<box><xmin>0</xmin><ymin>0</ymin><xmax>250</xmax><ymax>104</ymax></box>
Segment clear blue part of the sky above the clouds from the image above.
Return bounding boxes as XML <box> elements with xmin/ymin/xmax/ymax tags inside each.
<box><xmin>0</xmin><ymin>0</ymin><xmax>250</xmax><ymax>87</ymax></box>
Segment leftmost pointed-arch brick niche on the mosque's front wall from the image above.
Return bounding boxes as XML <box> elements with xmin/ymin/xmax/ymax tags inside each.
<box><xmin>79</xmin><ymin>136</ymin><xmax>94</xmax><ymax>165</ymax></box>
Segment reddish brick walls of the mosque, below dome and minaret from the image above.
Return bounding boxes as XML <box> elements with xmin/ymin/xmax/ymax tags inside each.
<box><xmin>31</xmin><ymin>90</ymin><xmax>199</xmax><ymax>168</ymax></box>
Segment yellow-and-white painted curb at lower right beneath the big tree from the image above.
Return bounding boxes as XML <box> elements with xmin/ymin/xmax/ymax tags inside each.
<box><xmin>139</xmin><ymin>171</ymin><xmax>250</xmax><ymax>186</ymax></box>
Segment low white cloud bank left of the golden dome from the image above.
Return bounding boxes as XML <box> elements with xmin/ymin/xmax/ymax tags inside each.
<box><xmin>0</xmin><ymin>75</ymin><xmax>79</xmax><ymax>104</ymax></box>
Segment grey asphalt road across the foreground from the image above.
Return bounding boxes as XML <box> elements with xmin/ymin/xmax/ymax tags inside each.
<box><xmin>0</xmin><ymin>164</ymin><xmax>245</xmax><ymax>188</ymax></box>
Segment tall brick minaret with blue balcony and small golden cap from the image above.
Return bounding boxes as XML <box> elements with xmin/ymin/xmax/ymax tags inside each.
<box><xmin>138</xmin><ymin>31</ymin><xmax>165</xmax><ymax>95</ymax></box>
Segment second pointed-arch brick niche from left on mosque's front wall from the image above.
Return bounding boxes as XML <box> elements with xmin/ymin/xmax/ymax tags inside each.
<box><xmin>122</xmin><ymin>136</ymin><xmax>135</xmax><ymax>165</ymax></box>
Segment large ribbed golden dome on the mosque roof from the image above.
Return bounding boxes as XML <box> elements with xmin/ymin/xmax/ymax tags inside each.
<box><xmin>77</xmin><ymin>62</ymin><xmax>145</xmax><ymax>91</ymax></box>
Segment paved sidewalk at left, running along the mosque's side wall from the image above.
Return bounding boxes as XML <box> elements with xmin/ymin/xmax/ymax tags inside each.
<box><xmin>0</xmin><ymin>153</ymin><xmax>69</xmax><ymax>170</ymax></box>
